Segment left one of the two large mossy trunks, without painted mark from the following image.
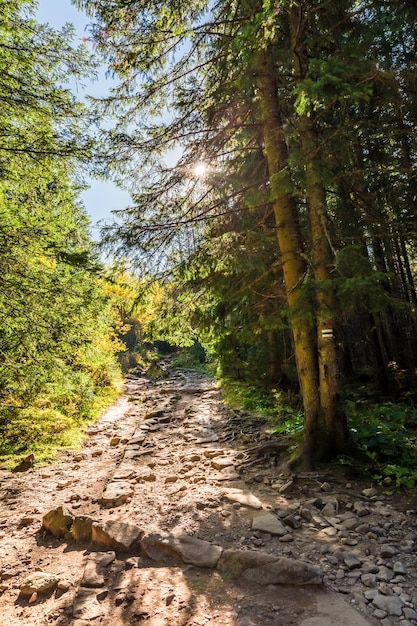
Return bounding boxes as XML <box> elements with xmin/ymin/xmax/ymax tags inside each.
<box><xmin>258</xmin><ymin>50</ymin><xmax>320</xmax><ymax>468</ymax></box>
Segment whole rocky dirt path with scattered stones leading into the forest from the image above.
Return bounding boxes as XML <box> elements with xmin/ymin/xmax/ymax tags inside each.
<box><xmin>0</xmin><ymin>370</ymin><xmax>417</xmax><ymax>626</ymax></box>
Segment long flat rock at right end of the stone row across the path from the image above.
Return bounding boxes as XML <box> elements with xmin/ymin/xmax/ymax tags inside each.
<box><xmin>218</xmin><ymin>550</ymin><xmax>323</xmax><ymax>585</ymax></box>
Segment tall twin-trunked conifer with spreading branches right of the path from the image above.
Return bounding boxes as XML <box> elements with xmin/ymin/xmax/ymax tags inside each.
<box><xmin>78</xmin><ymin>0</ymin><xmax>416</xmax><ymax>466</ymax></box>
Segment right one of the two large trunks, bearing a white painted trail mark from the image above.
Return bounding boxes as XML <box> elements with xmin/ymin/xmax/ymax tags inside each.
<box><xmin>290</xmin><ymin>7</ymin><xmax>354</xmax><ymax>460</ymax></box>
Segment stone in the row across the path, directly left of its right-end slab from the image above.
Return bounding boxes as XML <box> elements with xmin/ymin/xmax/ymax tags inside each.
<box><xmin>141</xmin><ymin>534</ymin><xmax>223</xmax><ymax>568</ymax></box>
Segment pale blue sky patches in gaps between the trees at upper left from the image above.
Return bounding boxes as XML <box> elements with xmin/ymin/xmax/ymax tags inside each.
<box><xmin>37</xmin><ymin>0</ymin><xmax>130</xmax><ymax>239</ymax></box>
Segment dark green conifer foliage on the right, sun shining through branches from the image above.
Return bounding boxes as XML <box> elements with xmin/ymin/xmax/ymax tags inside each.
<box><xmin>76</xmin><ymin>0</ymin><xmax>417</xmax><ymax>465</ymax></box>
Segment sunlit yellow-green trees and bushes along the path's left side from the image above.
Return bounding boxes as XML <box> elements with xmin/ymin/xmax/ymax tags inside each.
<box><xmin>0</xmin><ymin>0</ymin><xmax>120</xmax><ymax>459</ymax></box>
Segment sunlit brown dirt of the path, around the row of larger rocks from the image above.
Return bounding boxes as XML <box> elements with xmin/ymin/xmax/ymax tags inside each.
<box><xmin>0</xmin><ymin>367</ymin><xmax>417</xmax><ymax>626</ymax></box>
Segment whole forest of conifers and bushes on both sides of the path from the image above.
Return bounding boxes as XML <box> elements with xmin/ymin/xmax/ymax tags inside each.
<box><xmin>0</xmin><ymin>0</ymin><xmax>417</xmax><ymax>480</ymax></box>
